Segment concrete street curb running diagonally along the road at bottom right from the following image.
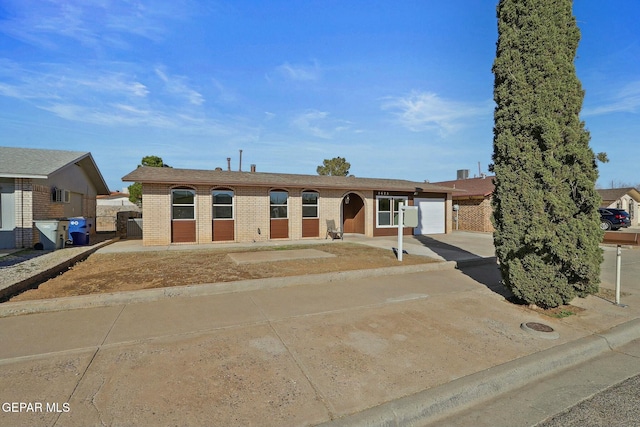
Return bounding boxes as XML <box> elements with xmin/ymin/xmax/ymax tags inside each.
<box><xmin>319</xmin><ymin>319</ymin><xmax>640</xmax><ymax>427</ymax></box>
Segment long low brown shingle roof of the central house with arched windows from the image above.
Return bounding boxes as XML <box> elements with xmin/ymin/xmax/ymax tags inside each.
<box><xmin>122</xmin><ymin>167</ymin><xmax>455</xmax><ymax>193</ymax></box>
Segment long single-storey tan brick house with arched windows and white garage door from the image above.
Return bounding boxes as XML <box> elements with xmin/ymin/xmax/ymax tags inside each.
<box><xmin>122</xmin><ymin>167</ymin><xmax>455</xmax><ymax>245</ymax></box>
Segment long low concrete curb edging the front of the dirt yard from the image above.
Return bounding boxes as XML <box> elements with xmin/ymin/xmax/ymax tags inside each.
<box><xmin>0</xmin><ymin>261</ymin><xmax>456</xmax><ymax>318</ymax></box>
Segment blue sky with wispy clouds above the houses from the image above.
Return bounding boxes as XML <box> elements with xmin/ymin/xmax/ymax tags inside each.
<box><xmin>0</xmin><ymin>0</ymin><xmax>640</xmax><ymax>190</ymax></box>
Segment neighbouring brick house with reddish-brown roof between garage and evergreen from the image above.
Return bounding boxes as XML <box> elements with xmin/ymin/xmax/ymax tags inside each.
<box><xmin>433</xmin><ymin>175</ymin><xmax>494</xmax><ymax>232</ymax></box>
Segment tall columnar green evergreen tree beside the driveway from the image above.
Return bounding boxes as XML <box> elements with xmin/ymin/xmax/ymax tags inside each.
<box><xmin>493</xmin><ymin>0</ymin><xmax>602</xmax><ymax>308</ymax></box>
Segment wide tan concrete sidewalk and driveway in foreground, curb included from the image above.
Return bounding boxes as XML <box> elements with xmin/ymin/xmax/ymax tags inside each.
<box><xmin>0</xmin><ymin>233</ymin><xmax>640</xmax><ymax>426</ymax></box>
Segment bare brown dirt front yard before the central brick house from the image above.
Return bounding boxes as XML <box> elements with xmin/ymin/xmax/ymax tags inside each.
<box><xmin>10</xmin><ymin>243</ymin><xmax>437</xmax><ymax>301</ymax></box>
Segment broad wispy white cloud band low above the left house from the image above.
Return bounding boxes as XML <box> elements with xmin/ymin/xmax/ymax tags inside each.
<box><xmin>0</xmin><ymin>60</ymin><xmax>249</xmax><ymax>137</ymax></box>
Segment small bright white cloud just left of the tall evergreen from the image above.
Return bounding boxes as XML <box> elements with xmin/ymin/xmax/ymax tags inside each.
<box><xmin>382</xmin><ymin>91</ymin><xmax>492</xmax><ymax>134</ymax></box>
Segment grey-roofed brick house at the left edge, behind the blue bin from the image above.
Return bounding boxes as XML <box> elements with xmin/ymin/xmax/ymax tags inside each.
<box><xmin>0</xmin><ymin>147</ymin><xmax>109</xmax><ymax>249</ymax></box>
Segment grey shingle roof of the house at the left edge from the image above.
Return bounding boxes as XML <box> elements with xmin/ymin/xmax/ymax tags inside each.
<box><xmin>0</xmin><ymin>147</ymin><xmax>109</xmax><ymax>194</ymax></box>
